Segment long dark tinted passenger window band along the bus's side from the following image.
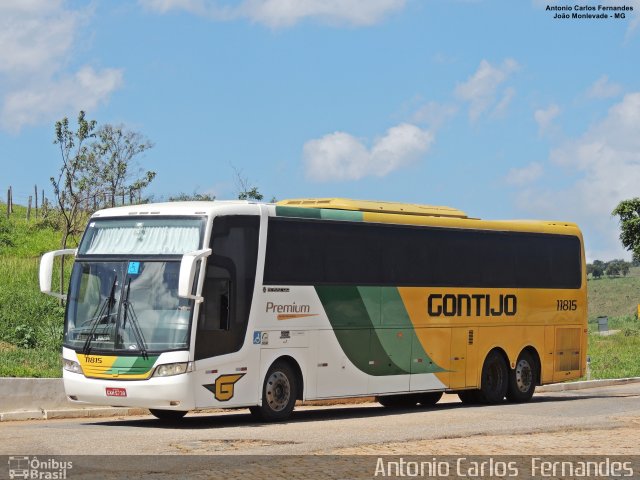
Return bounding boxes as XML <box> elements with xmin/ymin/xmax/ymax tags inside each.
<box><xmin>264</xmin><ymin>217</ymin><xmax>582</xmax><ymax>288</ymax></box>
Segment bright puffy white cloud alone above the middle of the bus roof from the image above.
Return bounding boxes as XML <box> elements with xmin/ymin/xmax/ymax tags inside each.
<box><xmin>303</xmin><ymin>123</ymin><xmax>434</xmax><ymax>182</ymax></box>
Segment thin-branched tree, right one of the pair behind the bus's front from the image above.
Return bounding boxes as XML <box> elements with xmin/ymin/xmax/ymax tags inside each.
<box><xmin>92</xmin><ymin>124</ymin><xmax>156</xmax><ymax>207</ymax></box>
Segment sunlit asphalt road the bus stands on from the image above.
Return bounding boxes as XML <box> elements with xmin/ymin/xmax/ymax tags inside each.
<box><xmin>0</xmin><ymin>383</ymin><xmax>640</xmax><ymax>455</ymax></box>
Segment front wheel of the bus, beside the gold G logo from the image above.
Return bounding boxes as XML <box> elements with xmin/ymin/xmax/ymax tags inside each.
<box><xmin>249</xmin><ymin>361</ymin><xmax>298</xmax><ymax>422</ymax></box>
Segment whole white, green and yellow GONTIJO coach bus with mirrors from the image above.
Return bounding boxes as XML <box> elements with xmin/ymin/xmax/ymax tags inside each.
<box><xmin>40</xmin><ymin>199</ymin><xmax>587</xmax><ymax>420</ymax></box>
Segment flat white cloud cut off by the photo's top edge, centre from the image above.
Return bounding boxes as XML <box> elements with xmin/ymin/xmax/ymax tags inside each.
<box><xmin>139</xmin><ymin>0</ymin><xmax>406</xmax><ymax>28</ymax></box>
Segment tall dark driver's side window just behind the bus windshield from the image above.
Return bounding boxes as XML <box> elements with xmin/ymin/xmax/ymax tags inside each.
<box><xmin>195</xmin><ymin>215</ymin><xmax>260</xmax><ymax>360</ymax></box>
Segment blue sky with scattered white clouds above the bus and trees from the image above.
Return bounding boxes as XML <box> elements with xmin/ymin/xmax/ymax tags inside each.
<box><xmin>0</xmin><ymin>0</ymin><xmax>640</xmax><ymax>261</ymax></box>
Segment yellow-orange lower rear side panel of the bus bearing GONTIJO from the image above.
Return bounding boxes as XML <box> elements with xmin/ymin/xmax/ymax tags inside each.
<box><xmin>398</xmin><ymin>287</ymin><xmax>587</xmax><ymax>389</ymax></box>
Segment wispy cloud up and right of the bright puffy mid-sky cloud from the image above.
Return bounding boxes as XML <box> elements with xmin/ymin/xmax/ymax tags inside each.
<box><xmin>455</xmin><ymin>59</ymin><xmax>518</xmax><ymax>121</ymax></box>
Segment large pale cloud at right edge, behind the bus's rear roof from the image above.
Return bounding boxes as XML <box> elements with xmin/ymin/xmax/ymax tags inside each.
<box><xmin>518</xmin><ymin>92</ymin><xmax>640</xmax><ymax>259</ymax></box>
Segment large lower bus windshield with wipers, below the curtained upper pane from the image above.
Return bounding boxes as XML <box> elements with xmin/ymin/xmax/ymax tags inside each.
<box><xmin>64</xmin><ymin>260</ymin><xmax>193</xmax><ymax>353</ymax></box>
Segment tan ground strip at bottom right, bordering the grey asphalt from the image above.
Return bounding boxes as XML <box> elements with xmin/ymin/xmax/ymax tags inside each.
<box><xmin>330</xmin><ymin>426</ymin><xmax>640</xmax><ymax>455</ymax></box>
